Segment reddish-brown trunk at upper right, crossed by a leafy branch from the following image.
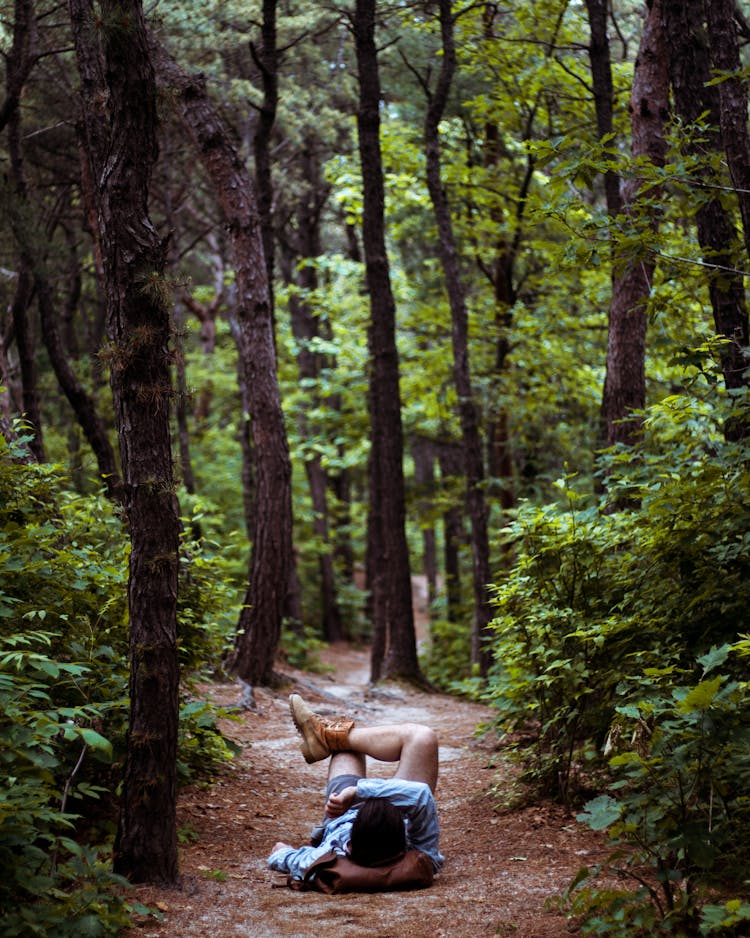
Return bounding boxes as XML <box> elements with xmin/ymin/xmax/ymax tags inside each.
<box><xmin>601</xmin><ymin>0</ymin><xmax>669</xmax><ymax>446</ymax></box>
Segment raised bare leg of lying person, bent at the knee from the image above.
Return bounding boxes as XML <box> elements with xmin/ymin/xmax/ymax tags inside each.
<box><xmin>346</xmin><ymin>723</ymin><xmax>438</xmax><ymax>791</ymax></box>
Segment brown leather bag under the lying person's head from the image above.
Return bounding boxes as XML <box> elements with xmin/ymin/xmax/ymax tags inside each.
<box><xmin>287</xmin><ymin>850</ymin><xmax>434</xmax><ymax>895</ymax></box>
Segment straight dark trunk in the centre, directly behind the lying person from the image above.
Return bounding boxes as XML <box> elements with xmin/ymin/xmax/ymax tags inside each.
<box><xmin>354</xmin><ymin>0</ymin><xmax>422</xmax><ymax>680</ymax></box>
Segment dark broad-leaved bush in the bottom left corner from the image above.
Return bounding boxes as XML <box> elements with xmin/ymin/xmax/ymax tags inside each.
<box><xmin>0</xmin><ymin>632</ymin><xmax>134</xmax><ymax>936</ymax></box>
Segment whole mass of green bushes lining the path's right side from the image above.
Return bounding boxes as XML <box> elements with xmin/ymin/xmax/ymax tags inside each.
<box><xmin>487</xmin><ymin>378</ymin><xmax>750</xmax><ymax>935</ymax></box>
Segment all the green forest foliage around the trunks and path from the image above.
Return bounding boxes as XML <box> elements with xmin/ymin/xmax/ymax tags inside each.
<box><xmin>0</xmin><ymin>0</ymin><xmax>750</xmax><ymax>936</ymax></box>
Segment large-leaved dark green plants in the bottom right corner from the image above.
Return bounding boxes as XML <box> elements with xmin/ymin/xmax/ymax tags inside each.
<box><xmin>573</xmin><ymin>645</ymin><xmax>750</xmax><ymax>935</ymax></box>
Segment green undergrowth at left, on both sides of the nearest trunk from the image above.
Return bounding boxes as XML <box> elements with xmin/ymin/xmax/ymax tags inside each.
<box><xmin>0</xmin><ymin>427</ymin><xmax>238</xmax><ymax>936</ymax></box>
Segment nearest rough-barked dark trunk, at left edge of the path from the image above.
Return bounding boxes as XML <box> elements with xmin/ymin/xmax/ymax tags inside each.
<box><xmin>69</xmin><ymin>0</ymin><xmax>184</xmax><ymax>883</ymax></box>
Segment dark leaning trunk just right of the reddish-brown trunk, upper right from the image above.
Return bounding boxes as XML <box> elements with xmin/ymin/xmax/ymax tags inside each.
<box><xmin>662</xmin><ymin>0</ymin><xmax>748</xmax><ymax>416</ymax></box>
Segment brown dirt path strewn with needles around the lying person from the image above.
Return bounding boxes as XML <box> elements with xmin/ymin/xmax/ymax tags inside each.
<box><xmin>128</xmin><ymin>647</ymin><xmax>612</xmax><ymax>938</ymax></box>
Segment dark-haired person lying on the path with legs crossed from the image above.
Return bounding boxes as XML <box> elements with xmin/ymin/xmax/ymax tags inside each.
<box><xmin>267</xmin><ymin>694</ymin><xmax>445</xmax><ymax>880</ymax></box>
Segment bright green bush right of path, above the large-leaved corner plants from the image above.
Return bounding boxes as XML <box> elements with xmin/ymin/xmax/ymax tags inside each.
<box><xmin>486</xmin><ymin>398</ymin><xmax>750</xmax><ymax>800</ymax></box>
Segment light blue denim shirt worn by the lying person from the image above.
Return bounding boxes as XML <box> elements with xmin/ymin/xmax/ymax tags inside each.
<box><xmin>268</xmin><ymin>778</ymin><xmax>445</xmax><ymax>879</ymax></box>
